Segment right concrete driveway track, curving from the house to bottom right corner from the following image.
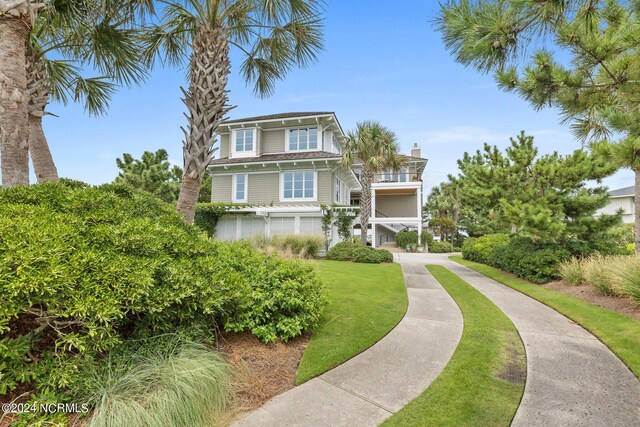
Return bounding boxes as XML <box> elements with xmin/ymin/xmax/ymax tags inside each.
<box><xmin>396</xmin><ymin>254</ymin><xmax>640</xmax><ymax>427</ymax></box>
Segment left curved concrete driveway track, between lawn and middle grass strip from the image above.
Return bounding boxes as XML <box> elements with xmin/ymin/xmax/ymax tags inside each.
<box><xmin>234</xmin><ymin>262</ymin><xmax>463</xmax><ymax>426</ymax></box>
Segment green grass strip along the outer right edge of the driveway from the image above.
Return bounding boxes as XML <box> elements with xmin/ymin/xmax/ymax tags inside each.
<box><xmin>449</xmin><ymin>255</ymin><xmax>640</xmax><ymax>378</ymax></box>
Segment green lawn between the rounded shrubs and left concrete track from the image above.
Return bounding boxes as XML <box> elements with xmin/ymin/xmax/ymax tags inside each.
<box><xmin>296</xmin><ymin>261</ymin><xmax>407</xmax><ymax>384</ymax></box>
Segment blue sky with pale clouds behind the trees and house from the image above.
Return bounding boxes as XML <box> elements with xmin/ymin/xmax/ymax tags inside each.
<box><xmin>42</xmin><ymin>0</ymin><xmax>633</xmax><ymax>193</ymax></box>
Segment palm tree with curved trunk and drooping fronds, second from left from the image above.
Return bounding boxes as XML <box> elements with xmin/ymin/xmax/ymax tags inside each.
<box><xmin>26</xmin><ymin>0</ymin><xmax>151</xmax><ymax>182</ymax></box>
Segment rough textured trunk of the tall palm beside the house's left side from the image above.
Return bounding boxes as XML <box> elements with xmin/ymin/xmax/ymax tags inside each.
<box><xmin>176</xmin><ymin>25</ymin><xmax>231</xmax><ymax>223</ymax></box>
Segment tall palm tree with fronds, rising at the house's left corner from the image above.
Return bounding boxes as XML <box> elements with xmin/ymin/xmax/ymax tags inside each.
<box><xmin>147</xmin><ymin>0</ymin><xmax>322</xmax><ymax>223</ymax></box>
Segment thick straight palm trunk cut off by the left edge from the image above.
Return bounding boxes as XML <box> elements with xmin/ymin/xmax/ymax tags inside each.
<box><xmin>0</xmin><ymin>14</ymin><xmax>29</xmax><ymax>188</ymax></box>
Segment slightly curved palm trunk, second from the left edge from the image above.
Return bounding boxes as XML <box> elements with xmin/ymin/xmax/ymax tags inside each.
<box><xmin>27</xmin><ymin>51</ymin><xmax>58</xmax><ymax>182</ymax></box>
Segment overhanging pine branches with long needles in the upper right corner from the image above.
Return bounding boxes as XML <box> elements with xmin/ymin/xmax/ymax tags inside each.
<box><xmin>438</xmin><ymin>0</ymin><xmax>640</xmax><ymax>253</ymax></box>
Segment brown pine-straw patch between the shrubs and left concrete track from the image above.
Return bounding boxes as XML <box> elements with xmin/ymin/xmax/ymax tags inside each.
<box><xmin>218</xmin><ymin>333</ymin><xmax>311</xmax><ymax>415</ymax></box>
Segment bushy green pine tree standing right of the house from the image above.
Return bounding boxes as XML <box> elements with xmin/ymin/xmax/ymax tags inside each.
<box><xmin>451</xmin><ymin>132</ymin><xmax>620</xmax><ymax>242</ymax></box>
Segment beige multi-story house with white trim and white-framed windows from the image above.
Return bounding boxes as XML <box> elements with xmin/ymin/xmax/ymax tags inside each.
<box><xmin>209</xmin><ymin>112</ymin><xmax>426</xmax><ymax>249</ymax></box>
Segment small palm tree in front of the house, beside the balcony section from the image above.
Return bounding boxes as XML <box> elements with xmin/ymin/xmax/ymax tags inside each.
<box><xmin>342</xmin><ymin>121</ymin><xmax>406</xmax><ymax>245</ymax></box>
